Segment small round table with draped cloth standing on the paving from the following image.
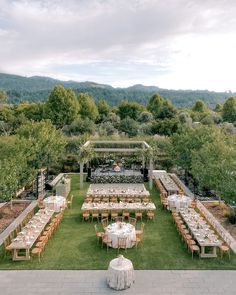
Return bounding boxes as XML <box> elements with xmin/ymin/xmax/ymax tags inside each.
<box><xmin>107</xmin><ymin>255</ymin><xmax>134</xmax><ymax>290</ymax></box>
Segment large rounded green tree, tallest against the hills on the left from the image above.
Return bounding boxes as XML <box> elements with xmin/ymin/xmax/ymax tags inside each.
<box><xmin>46</xmin><ymin>85</ymin><xmax>80</xmax><ymax>128</ymax></box>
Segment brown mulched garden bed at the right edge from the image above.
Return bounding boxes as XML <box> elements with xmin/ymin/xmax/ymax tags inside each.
<box><xmin>202</xmin><ymin>201</ymin><xmax>236</xmax><ymax>239</ymax></box>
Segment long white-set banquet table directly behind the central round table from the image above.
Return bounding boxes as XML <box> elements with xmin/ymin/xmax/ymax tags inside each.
<box><xmin>81</xmin><ymin>202</ymin><xmax>156</xmax><ymax>211</ymax></box>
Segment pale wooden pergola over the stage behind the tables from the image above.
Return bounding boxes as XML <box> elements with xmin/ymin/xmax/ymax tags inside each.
<box><xmin>80</xmin><ymin>140</ymin><xmax>153</xmax><ymax>189</ymax></box>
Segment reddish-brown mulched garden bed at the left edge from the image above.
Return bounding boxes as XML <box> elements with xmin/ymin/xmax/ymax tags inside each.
<box><xmin>0</xmin><ymin>201</ymin><xmax>31</xmax><ymax>233</ymax></box>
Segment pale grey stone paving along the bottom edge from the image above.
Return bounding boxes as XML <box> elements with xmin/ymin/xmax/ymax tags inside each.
<box><xmin>0</xmin><ymin>270</ymin><xmax>236</xmax><ymax>295</ymax></box>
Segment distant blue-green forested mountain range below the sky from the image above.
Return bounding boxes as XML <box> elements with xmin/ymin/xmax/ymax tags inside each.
<box><xmin>0</xmin><ymin>73</ymin><xmax>232</xmax><ymax>107</ymax></box>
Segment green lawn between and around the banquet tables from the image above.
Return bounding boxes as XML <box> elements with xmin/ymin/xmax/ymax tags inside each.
<box><xmin>0</xmin><ymin>175</ymin><xmax>236</xmax><ymax>269</ymax></box>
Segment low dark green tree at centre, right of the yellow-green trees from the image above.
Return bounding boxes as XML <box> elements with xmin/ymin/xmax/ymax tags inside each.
<box><xmin>118</xmin><ymin>100</ymin><xmax>144</xmax><ymax>120</ymax></box>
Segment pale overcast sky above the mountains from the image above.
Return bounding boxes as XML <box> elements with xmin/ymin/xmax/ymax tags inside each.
<box><xmin>0</xmin><ymin>0</ymin><xmax>236</xmax><ymax>91</ymax></box>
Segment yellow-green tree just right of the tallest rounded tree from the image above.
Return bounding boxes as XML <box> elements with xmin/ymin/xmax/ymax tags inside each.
<box><xmin>78</xmin><ymin>93</ymin><xmax>99</xmax><ymax>121</ymax></box>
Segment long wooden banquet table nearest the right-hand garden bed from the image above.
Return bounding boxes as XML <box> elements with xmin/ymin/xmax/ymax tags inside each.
<box><xmin>180</xmin><ymin>208</ymin><xmax>222</xmax><ymax>258</ymax></box>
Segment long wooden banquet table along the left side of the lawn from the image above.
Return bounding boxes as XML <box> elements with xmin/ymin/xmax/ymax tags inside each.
<box><xmin>8</xmin><ymin>209</ymin><xmax>54</xmax><ymax>260</ymax></box>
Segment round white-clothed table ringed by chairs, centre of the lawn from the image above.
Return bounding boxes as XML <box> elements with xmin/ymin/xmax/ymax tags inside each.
<box><xmin>106</xmin><ymin>222</ymin><xmax>136</xmax><ymax>248</ymax></box>
